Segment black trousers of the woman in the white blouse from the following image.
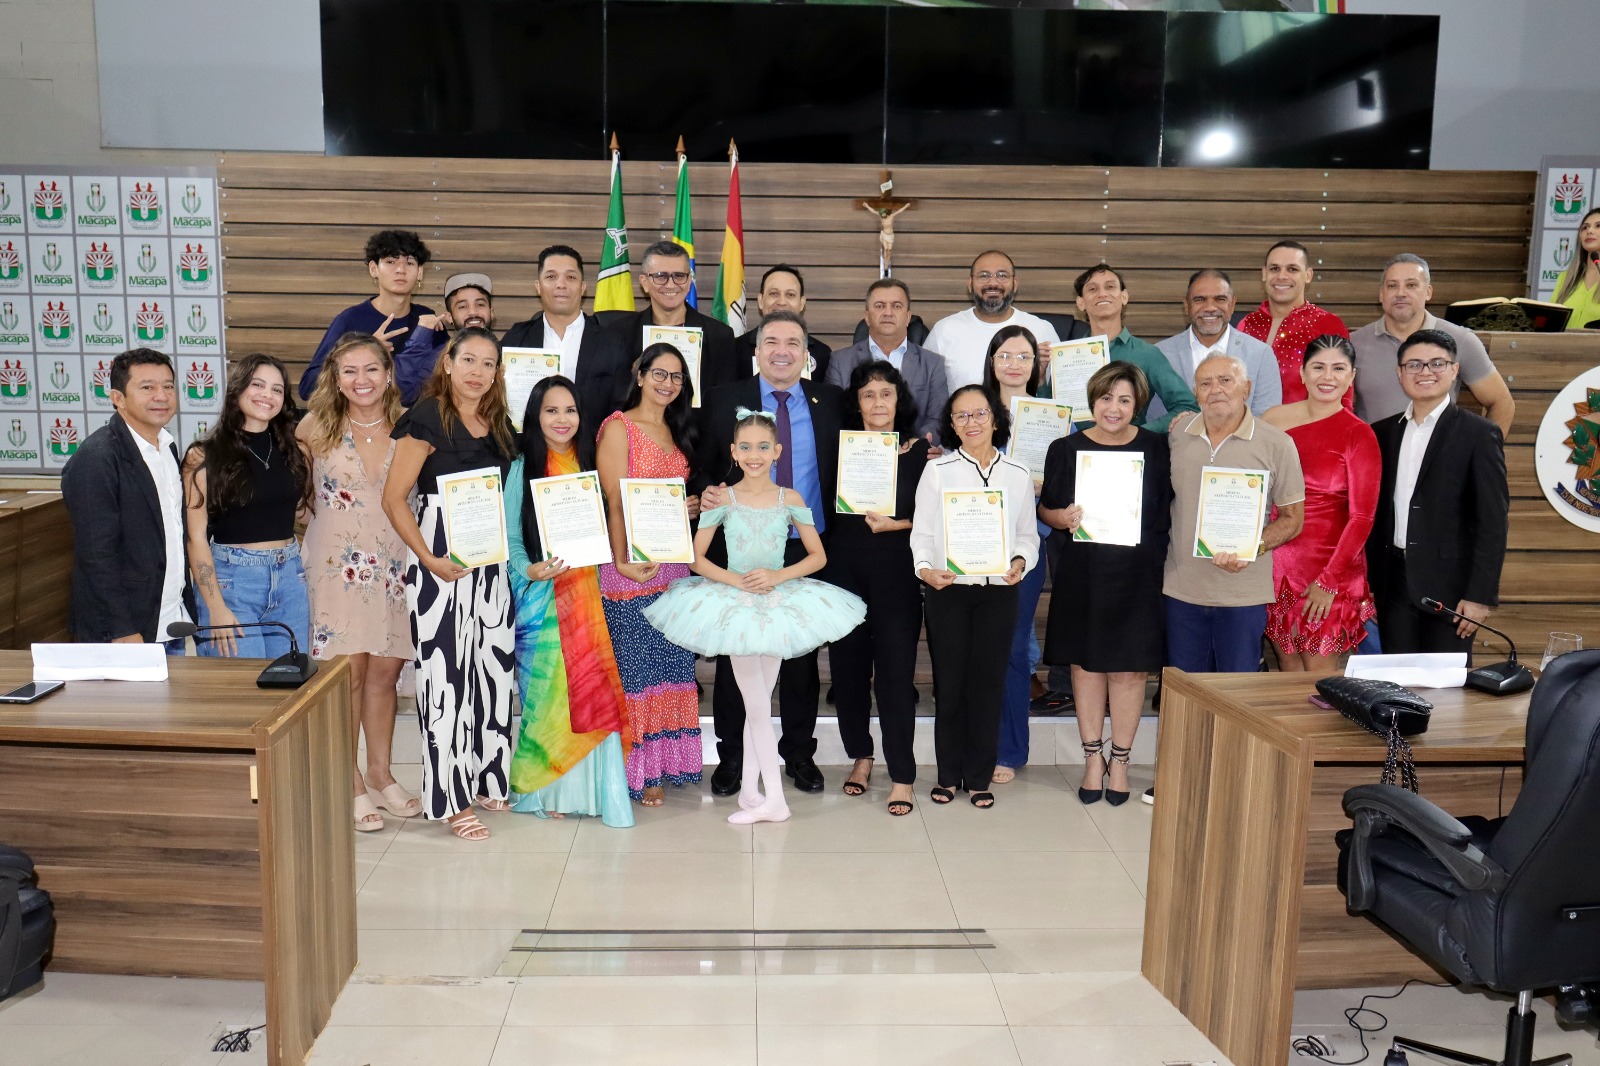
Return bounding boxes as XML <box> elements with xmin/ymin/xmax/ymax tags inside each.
<box><xmin>923</xmin><ymin>584</ymin><xmax>1018</xmax><ymax>792</ymax></box>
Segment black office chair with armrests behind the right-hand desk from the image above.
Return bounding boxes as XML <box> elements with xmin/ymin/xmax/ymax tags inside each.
<box><xmin>1339</xmin><ymin>650</ymin><xmax>1600</xmax><ymax>1066</ymax></box>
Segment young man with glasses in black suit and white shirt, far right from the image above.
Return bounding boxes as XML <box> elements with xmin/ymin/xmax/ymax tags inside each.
<box><xmin>1366</xmin><ymin>330</ymin><xmax>1510</xmax><ymax>653</ymax></box>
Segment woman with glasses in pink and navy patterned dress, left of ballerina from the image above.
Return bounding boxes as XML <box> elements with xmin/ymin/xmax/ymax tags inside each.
<box><xmin>597</xmin><ymin>344</ymin><xmax>704</xmax><ymax>807</ymax></box>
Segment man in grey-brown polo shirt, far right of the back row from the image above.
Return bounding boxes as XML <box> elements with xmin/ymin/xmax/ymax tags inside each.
<box><xmin>1350</xmin><ymin>251</ymin><xmax>1517</xmax><ymax>437</ymax></box>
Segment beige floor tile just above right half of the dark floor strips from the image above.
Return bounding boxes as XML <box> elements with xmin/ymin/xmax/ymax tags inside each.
<box><xmin>755</xmin><ymin>852</ymin><xmax>955</xmax><ymax>928</ymax></box>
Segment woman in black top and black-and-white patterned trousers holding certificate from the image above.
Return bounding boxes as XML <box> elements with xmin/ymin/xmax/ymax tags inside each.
<box><xmin>384</xmin><ymin>327</ymin><xmax>517</xmax><ymax>840</ymax></box>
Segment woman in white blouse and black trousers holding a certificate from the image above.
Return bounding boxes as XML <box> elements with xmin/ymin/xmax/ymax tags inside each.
<box><xmin>910</xmin><ymin>384</ymin><xmax>1038</xmax><ymax>808</ymax></box>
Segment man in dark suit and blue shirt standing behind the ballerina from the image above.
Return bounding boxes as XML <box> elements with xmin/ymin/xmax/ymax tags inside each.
<box><xmin>690</xmin><ymin>311</ymin><xmax>843</xmax><ymax>795</ymax></box>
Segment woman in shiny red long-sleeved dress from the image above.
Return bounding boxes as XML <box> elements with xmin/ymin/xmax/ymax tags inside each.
<box><xmin>1261</xmin><ymin>333</ymin><xmax>1382</xmax><ymax>674</ymax></box>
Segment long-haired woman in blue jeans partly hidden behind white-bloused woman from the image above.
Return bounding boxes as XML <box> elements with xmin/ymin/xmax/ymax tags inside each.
<box><xmin>984</xmin><ymin>325</ymin><xmax>1072</xmax><ymax>784</ymax></box>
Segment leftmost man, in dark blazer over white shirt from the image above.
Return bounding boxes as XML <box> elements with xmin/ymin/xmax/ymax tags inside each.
<box><xmin>61</xmin><ymin>347</ymin><xmax>194</xmax><ymax>643</ymax></box>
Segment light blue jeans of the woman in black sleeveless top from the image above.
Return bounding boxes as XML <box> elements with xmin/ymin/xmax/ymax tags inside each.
<box><xmin>195</xmin><ymin>543</ymin><xmax>310</xmax><ymax>659</ymax></box>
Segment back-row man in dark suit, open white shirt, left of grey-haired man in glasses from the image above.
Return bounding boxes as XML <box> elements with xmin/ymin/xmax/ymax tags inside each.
<box><xmin>502</xmin><ymin>245</ymin><xmax>638</xmax><ymax>426</ymax></box>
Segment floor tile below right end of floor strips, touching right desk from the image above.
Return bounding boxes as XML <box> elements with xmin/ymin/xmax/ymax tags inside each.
<box><xmin>994</xmin><ymin>973</ymin><xmax>1187</xmax><ymax>1026</ymax></box>
